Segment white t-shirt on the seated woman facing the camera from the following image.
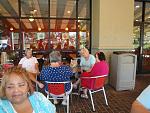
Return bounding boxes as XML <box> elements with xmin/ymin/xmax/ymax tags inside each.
<box><xmin>19</xmin><ymin>57</ymin><xmax>38</xmax><ymax>73</ymax></box>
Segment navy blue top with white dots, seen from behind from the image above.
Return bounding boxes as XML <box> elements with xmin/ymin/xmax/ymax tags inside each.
<box><xmin>40</xmin><ymin>65</ymin><xmax>73</xmax><ymax>91</ymax></box>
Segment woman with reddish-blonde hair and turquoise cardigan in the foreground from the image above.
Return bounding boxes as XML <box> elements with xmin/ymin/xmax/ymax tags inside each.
<box><xmin>0</xmin><ymin>67</ymin><xmax>56</xmax><ymax>113</ymax></box>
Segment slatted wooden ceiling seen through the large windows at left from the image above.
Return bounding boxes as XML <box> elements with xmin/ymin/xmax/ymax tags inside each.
<box><xmin>0</xmin><ymin>0</ymin><xmax>90</xmax><ymax>31</ymax></box>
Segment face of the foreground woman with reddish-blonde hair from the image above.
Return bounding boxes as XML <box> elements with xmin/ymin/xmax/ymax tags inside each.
<box><xmin>5</xmin><ymin>74</ymin><xmax>29</xmax><ymax>104</ymax></box>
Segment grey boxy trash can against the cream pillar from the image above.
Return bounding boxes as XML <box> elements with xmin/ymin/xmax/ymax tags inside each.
<box><xmin>109</xmin><ymin>52</ymin><xmax>137</xmax><ymax>91</ymax></box>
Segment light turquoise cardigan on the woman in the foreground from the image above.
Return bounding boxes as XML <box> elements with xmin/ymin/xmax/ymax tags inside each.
<box><xmin>0</xmin><ymin>92</ymin><xmax>56</xmax><ymax>113</ymax></box>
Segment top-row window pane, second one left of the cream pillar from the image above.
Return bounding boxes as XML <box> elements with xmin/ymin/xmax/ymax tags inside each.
<box><xmin>50</xmin><ymin>0</ymin><xmax>76</xmax><ymax>18</ymax></box>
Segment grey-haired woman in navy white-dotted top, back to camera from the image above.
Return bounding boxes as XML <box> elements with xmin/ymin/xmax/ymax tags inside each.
<box><xmin>40</xmin><ymin>51</ymin><xmax>73</xmax><ymax>105</ymax></box>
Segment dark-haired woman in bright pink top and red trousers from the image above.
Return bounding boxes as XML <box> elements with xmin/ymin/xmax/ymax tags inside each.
<box><xmin>81</xmin><ymin>52</ymin><xmax>109</xmax><ymax>98</ymax></box>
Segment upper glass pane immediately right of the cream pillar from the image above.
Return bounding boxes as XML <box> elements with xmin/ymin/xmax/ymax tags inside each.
<box><xmin>134</xmin><ymin>2</ymin><xmax>142</xmax><ymax>22</ymax></box>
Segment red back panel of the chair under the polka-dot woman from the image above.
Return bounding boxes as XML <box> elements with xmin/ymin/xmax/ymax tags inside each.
<box><xmin>48</xmin><ymin>83</ymin><xmax>65</xmax><ymax>95</ymax></box>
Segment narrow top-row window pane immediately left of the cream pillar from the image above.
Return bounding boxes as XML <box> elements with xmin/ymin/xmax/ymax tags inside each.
<box><xmin>78</xmin><ymin>0</ymin><xmax>90</xmax><ymax>18</ymax></box>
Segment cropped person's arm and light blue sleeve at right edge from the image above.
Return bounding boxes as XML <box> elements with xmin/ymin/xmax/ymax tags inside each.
<box><xmin>131</xmin><ymin>85</ymin><xmax>150</xmax><ymax>113</ymax></box>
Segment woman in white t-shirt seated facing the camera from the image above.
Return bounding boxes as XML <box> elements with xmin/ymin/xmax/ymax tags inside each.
<box><xmin>18</xmin><ymin>49</ymin><xmax>44</xmax><ymax>88</ymax></box>
